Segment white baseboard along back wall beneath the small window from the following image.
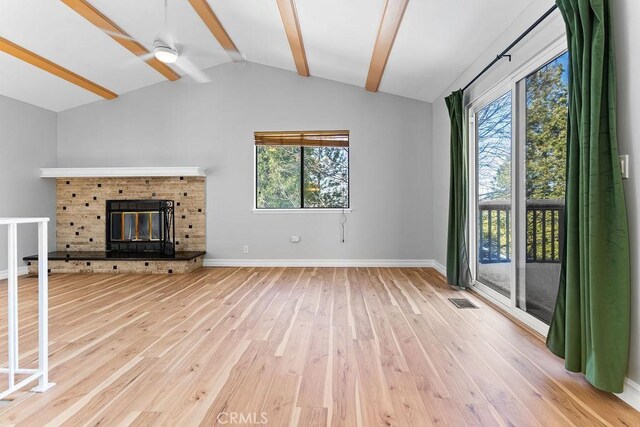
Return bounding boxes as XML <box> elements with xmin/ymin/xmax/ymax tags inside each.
<box><xmin>203</xmin><ymin>258</ymin><xmax>444</xmax><ymax>272</ymax></box>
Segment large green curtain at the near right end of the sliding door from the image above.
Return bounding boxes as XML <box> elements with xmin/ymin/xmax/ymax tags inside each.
<box><xmin>547</xmin><ymin>0</ymin><xmax>630</xmax><ymax>393</ymax></box>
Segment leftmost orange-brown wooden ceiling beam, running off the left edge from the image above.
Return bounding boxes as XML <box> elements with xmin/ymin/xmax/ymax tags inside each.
<box><xmin>0</xmin><ymin>37</ymin><xmax>118</xmax><ymax>99</ymax></box>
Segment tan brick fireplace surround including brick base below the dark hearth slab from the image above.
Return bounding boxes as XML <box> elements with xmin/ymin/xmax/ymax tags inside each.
<box><xmin>36</xmin><ymin>176</ymin><xmax>206</xmax><ymax>274</ymax></box>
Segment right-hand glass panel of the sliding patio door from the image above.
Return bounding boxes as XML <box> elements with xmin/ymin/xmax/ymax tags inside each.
<box><xmin>517</xmin><ymin>53</ymin><xmax>569</xmax><ymax>324</ymax></box>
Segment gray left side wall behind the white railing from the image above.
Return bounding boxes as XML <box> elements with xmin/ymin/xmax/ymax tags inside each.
<box><xmin>0</xmin><ymin>96</ymin><xmax>56</xmax><ymax>271</ymax></box>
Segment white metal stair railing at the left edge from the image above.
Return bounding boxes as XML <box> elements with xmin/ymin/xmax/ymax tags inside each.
<box><xmin>0</xmin><ymin>218</ymin><xmax>54</xmax><ymax>399</ymax></box>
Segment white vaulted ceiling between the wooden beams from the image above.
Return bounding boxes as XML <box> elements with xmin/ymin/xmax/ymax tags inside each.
<box><xmin>0</xmin><ymin>0</ymin><xmax>533</xmax><ymax>111</ymax></box>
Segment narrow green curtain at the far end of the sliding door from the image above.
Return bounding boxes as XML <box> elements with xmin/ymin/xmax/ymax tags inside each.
<box><xmin>445</xmin><ymin>90</ymin><xmax>471</xmax><ymax>287</ymax></box>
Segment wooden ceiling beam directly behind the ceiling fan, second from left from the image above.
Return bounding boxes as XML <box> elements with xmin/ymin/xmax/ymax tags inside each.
<box><xmin>61</xmin><ymin>0</ymin><xmax>180</xmax><ymax>81</ymax></box>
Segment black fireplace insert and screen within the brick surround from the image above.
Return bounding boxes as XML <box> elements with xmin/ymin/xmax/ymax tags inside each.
<box><xmin>106</xmin><ymin>200</ymin><xmax>176</xmax><ymax>256</ymax></box>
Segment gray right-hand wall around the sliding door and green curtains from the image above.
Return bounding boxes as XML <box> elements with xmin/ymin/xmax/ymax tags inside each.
<box><xmin>431</xmin><ymin>0</ymin><xmax>640</xmax><ymax>394</ymax></box>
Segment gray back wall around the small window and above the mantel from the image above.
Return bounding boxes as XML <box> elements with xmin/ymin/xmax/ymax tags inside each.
<box><xmin>58</xmin><ymin>63</ymin><xmax>432</xmax><ymax>259</ymax></box>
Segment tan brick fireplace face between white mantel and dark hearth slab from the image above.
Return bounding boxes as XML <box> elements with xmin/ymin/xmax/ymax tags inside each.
<box><xmin>56</xmin><ymin>177</ymin><xmax>206</xmax><ymax>251</ymax></box>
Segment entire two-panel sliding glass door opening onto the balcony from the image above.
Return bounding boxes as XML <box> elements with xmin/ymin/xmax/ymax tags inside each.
<box><xmin>469</xmin><ymin>49</ymin><xmax>568</xmax><ymax>332</ymax></box>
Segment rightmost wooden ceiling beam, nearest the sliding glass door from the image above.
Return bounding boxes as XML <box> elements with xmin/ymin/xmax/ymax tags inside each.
<box><xmin>365</xmin><ymin>0</ymin><xmax>409</xmax><ymax>92</ymax></box>
